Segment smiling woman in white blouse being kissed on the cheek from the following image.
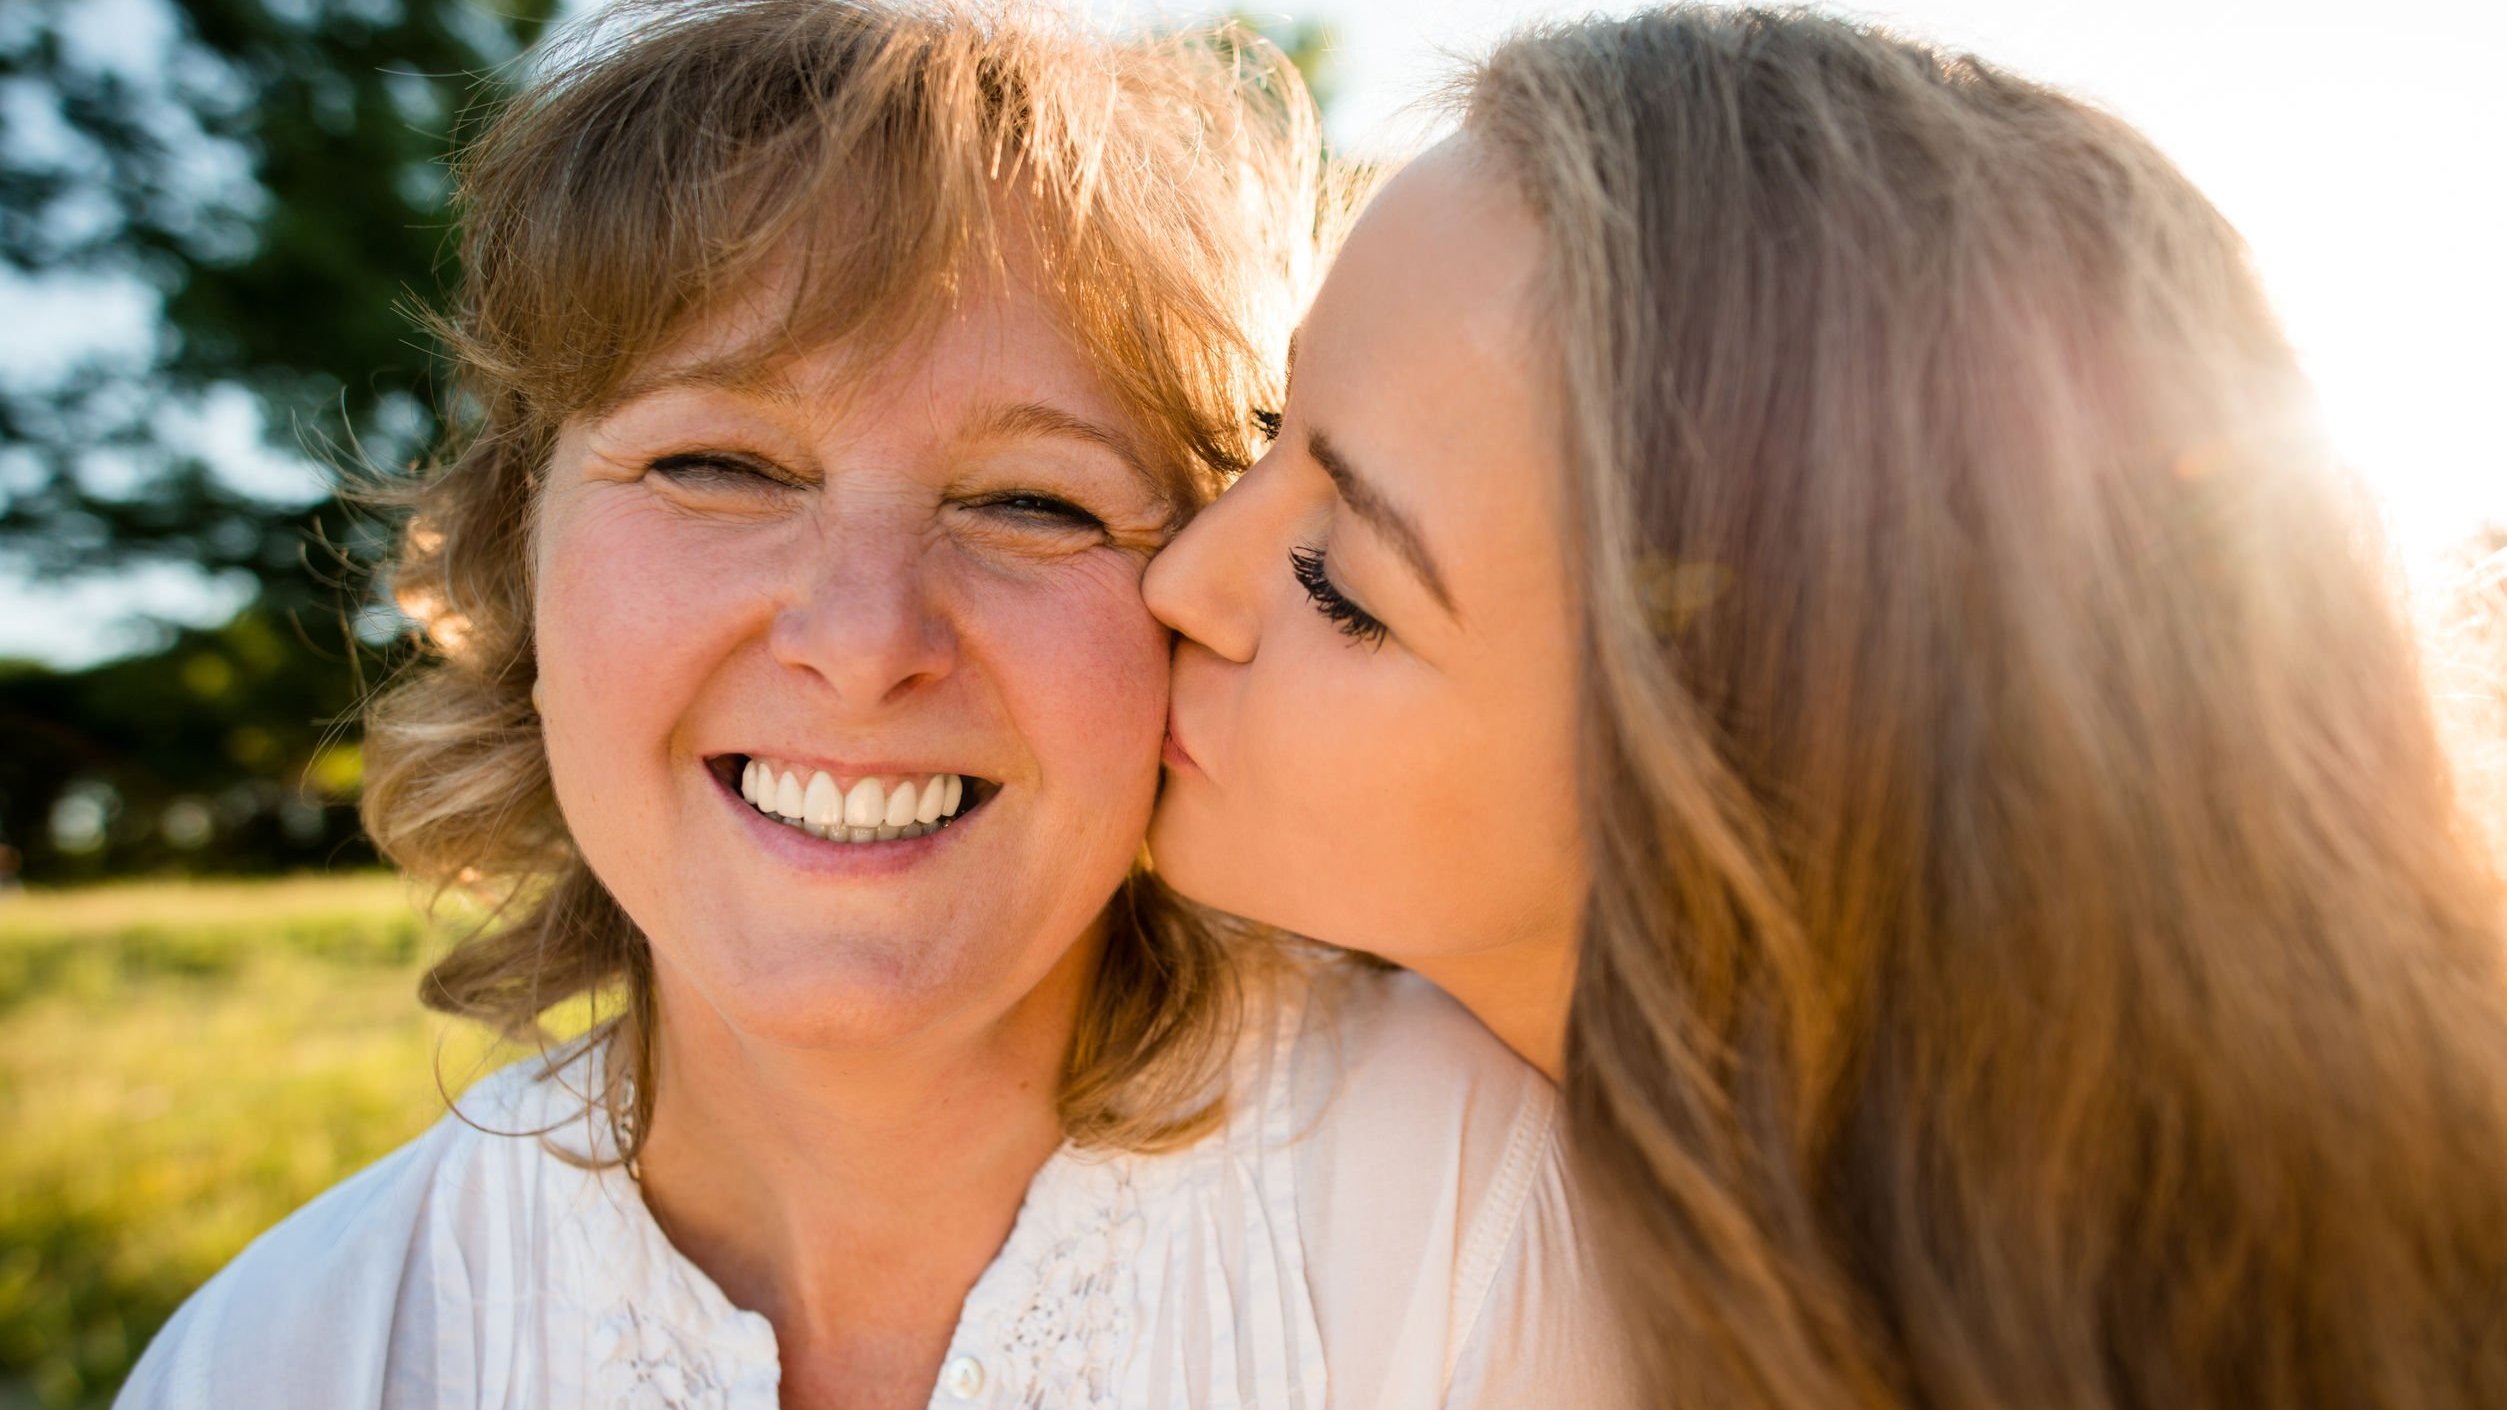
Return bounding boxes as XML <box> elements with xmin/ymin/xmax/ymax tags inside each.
<box><xmin>125</xmin><ymin>0</ymin><xmax>1599</xmax><ymax>1410</ymax></box>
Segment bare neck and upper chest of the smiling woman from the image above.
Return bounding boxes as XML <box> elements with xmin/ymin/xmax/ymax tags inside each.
<box><xmin>637</xmin><ymin>941</ymin><xmax>1096</xmax><ymax>1407</ymax></box>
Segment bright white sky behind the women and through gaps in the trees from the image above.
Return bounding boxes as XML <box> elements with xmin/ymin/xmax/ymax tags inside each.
<box><xmin>0</xmin><ymin>0</ymin><xmax>2507</xmax><ymax>662</ymax></box>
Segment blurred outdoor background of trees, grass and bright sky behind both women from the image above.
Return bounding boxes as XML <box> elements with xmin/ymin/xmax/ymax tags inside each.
<box><xmin>0</xmin><ymin>0</ymin><xmax>2507</xmax><ymax>1410</ymax></box>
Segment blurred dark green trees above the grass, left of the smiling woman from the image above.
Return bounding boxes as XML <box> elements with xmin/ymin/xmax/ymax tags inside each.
<box><xmin>0</xmin><ymin>0</ymin><xmax>559</xmax><ymax>876</ymax></box>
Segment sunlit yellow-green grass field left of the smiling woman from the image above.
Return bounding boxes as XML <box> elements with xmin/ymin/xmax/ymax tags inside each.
<box><xmin>0</xmin><ymin>873</ymin><xmax>516</xmax><ymax>1410</ymax></box>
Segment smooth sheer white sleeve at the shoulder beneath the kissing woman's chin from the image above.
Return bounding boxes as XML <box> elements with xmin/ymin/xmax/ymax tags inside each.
<box><xmin>1289</xmin><ymin>961</ymin><xmax>1625</xmax><ymax>1410</ymax></box>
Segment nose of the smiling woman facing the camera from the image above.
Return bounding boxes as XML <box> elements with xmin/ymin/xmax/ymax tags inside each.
<box><xmin>767</xmin><ymin>532</ymin><xmax>958</xmax><ymax>710</ymax></box>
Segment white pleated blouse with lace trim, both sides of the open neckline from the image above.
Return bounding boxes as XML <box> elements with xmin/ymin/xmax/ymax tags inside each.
<box><xmin>118</xmin><ymin>966</ymin><xmax>1609</xmax><ymax>1410</ymax></box>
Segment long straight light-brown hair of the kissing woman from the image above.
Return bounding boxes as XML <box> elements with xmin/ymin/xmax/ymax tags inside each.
<box><xmin>1467</xmin><ymin>8</ymin><xmax>2507</xmax><ymax>1410</ymax></box>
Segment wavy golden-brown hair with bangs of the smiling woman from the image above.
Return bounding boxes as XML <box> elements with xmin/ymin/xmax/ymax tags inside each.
<box><xmin>364</xmin><ymin>0</ymin><xmax>1321</xmax><ymax>1159</ymax></box>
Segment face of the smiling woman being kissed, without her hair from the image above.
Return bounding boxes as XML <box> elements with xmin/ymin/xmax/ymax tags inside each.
<box><xmin>531</xmin><ymin>253</ymin><xmax>1211</xmax><ymax>1063</ymax></box>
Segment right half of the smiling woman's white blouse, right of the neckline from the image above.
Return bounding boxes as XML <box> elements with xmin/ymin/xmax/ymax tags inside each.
<box><xmin>948</xmin><ymin>953</ymin><xmax>1584</xmax><ymax>1410</ymax></box>
